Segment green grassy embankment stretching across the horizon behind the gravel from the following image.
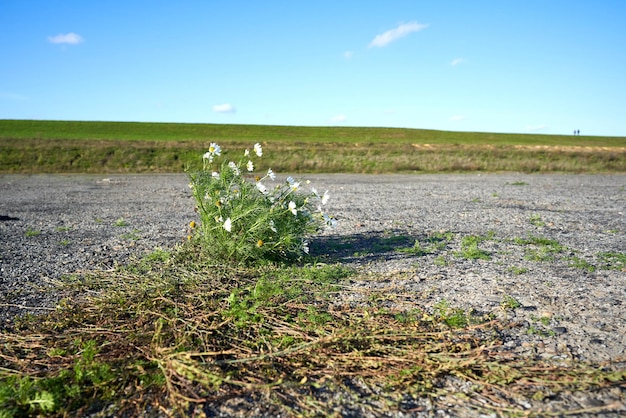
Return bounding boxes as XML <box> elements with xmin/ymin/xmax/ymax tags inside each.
<box><xmin>0</xmin><ymin>120</ymin><xmax>626</xmax><ymax>173</ymax></box>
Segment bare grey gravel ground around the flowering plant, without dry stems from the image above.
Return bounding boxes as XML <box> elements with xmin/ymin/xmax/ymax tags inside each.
<box><xmin>0</xmin><ymin>174</ymin><xmax>626</xmax><ymax>416</ymax></box>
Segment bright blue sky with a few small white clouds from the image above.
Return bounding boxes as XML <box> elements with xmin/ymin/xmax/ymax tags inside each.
<box><xmin>0</xmin><ymin>0</ymin><xmax>626</xmax><ymax>136</ymax></box>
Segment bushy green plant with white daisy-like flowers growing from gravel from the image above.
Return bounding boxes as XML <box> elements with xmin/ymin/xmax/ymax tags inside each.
<box><xmin>189</xmin><ymin>143</ymin><xmax>335</xmax><ymax>262</ymax></box>
